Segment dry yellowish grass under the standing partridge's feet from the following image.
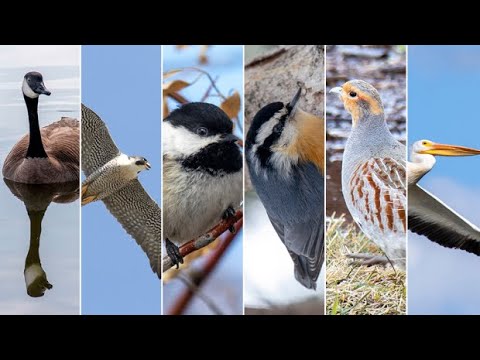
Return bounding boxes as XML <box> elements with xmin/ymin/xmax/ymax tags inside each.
<box><xmin>326</xmin><ymin>215</ymin><xmax>406</xmax><ymax>315</ymax></box>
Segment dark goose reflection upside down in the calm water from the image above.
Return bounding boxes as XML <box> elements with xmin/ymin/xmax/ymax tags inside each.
<box><xmin>3</xmin><ymin>178</ymin><xmax>79</xmax><ymax>297</ymax></box>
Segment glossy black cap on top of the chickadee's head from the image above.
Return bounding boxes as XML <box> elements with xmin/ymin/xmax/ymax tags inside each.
<box><xmin>165</xmin><ymin>103</ymin><xmax>233</xmax><ymax>137</ymax></box>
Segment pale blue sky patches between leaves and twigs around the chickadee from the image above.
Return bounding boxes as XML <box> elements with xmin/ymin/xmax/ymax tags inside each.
<box><xmin>163</xmin><ymin>45</ymin><xmax>243</xmax><ymax>314</ymax></box>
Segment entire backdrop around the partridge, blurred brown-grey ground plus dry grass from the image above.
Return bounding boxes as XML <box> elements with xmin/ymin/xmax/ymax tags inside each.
<box><xmin>326</xmin><ymin>45</ymin><xmax>407</xmax><ymax>315</ymax></box>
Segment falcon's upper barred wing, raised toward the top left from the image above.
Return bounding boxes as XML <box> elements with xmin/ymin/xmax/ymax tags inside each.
<box><xmin>81</xmin><ymin>104</ymin><xmax>120</xmax><ymax>176</ymax></box>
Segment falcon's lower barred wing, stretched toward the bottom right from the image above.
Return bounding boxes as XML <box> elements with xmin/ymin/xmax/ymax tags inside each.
<box><xmin>103</xmin><ymin>179</ymin><xmax>162</xmax><ymax>278</ymax></box>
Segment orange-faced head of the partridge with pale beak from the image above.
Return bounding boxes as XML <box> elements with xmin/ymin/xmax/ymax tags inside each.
<box><xmin>330</xmin><ymin>80</ymin><xmax>383</xmax><ymax>125</ymax></box>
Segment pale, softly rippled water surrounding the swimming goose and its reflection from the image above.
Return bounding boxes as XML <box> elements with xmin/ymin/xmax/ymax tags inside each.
<box><xmin>0</xmin><ymin>45</ymin><xmax>80</xmax><ymax>314</ymax></box>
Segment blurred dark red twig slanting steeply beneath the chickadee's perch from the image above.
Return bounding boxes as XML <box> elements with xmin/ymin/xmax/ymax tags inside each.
<box><xmin>168</xmin><ymin>217</ymin><xmax>243</xmax><ymax>315</ymax></box>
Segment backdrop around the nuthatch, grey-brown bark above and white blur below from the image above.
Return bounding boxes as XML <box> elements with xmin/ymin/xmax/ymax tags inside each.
<box><xmin>244</xmin><ymin>45</ymin><xmax>325</xmax><ymax>315</ymax></box>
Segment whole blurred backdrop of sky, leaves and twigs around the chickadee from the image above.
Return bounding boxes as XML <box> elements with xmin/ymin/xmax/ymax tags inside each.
<box><xmin>163</xmin><ymin>45</ymin><xmax>243</xmax><ymax>315</ymax></box>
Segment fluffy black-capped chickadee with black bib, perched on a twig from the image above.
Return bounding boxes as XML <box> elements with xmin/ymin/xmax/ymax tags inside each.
<box><xmin>163</xmin><ymin>102</ymin><xmax>243</xmax><ymax>268</ymax></box>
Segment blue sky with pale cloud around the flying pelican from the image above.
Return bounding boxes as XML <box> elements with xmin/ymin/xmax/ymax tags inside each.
<box><xmin>408</xmin><ymin>46</ymin><xmax>480</xmax><ymax>314</ymax></box>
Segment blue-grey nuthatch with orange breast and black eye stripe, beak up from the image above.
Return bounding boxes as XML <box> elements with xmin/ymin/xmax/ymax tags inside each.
<box><xmin>245</xmin><ymin>89</ymin><xmax>324</xmax><ymax>289</ymax></box>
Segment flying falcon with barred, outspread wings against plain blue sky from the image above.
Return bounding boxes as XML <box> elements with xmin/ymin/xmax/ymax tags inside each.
<box><xmin>82</xmin><ymin>104</ymin><xmax>161</xmax><ymax>278</ymax></box>
